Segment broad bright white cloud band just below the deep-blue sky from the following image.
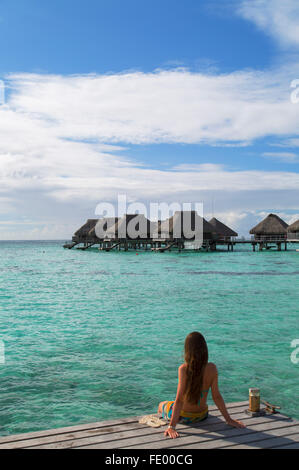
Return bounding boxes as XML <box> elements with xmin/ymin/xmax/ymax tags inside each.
<box><xmin>6</xmin><ymin>67</ymin><xmax>299</xmax><ymax>145</ymax></box>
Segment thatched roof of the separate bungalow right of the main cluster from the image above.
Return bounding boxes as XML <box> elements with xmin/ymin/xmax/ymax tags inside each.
<box><xmin>250</xmin><ymin>214</ymin><xmax>288</xmax><ymax>241</ymax></box>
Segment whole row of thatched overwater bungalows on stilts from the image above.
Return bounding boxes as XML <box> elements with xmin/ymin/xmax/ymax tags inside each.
<box><xmin>63</xmin><ymin>211</ymin><xmax>299</xmax><ymax>252</ymax></box>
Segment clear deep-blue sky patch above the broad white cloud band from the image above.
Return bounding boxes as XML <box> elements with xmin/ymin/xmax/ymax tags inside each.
<box><xmin>0</xmin><ymin>0</ymin><xmax>275</xmax><ymax>74</ymax></box>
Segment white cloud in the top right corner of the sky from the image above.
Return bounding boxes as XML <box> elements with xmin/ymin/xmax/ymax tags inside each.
<box><xmin>237</xmin><ymin>0</ymin><xmax>299</xmax><ymax>48</ymax></box>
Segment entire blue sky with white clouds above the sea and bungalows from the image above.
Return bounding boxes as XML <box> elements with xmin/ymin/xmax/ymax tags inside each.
<box><xmin>0</xmin><ymin>0</ymin><xmax>299</xmax><ymax>239</ymax></box>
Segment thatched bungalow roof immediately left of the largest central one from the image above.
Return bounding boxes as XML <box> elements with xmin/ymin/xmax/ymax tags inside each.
<box><xmin>105</xmin><ymin>214</ymin><xmax>151</xmax><ymax>240</ymax></box>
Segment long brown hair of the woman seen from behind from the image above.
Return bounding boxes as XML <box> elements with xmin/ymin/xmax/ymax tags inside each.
<box><xmin>185</xmin><ymin>331</ymin><xmax>209</xmax><ymax>403</ymax></box>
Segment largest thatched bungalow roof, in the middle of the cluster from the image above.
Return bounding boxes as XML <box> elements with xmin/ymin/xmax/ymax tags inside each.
<box><xmin>159</xmin><ymin>211</ymin><xmax>214</xmax><ymax>241</ymax></box>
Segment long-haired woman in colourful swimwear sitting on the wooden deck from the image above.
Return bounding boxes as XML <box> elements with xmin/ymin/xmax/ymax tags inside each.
<box><xmin>158</xmin><ymin>332</ymin><xmax>245</xmax><ymax>439</ymax></box>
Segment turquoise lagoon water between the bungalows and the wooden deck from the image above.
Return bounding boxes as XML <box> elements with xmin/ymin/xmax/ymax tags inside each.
<box><xmin>0</xmin><ymin>242</ymin><xmax>299</xmax><ymax>435</ymax></box>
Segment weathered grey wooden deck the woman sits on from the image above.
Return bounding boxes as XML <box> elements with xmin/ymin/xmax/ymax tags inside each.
<box><xmin>0</xmin><ymin>402</ymin><xmax>299</xmax><ymax>450</ymax></box>
